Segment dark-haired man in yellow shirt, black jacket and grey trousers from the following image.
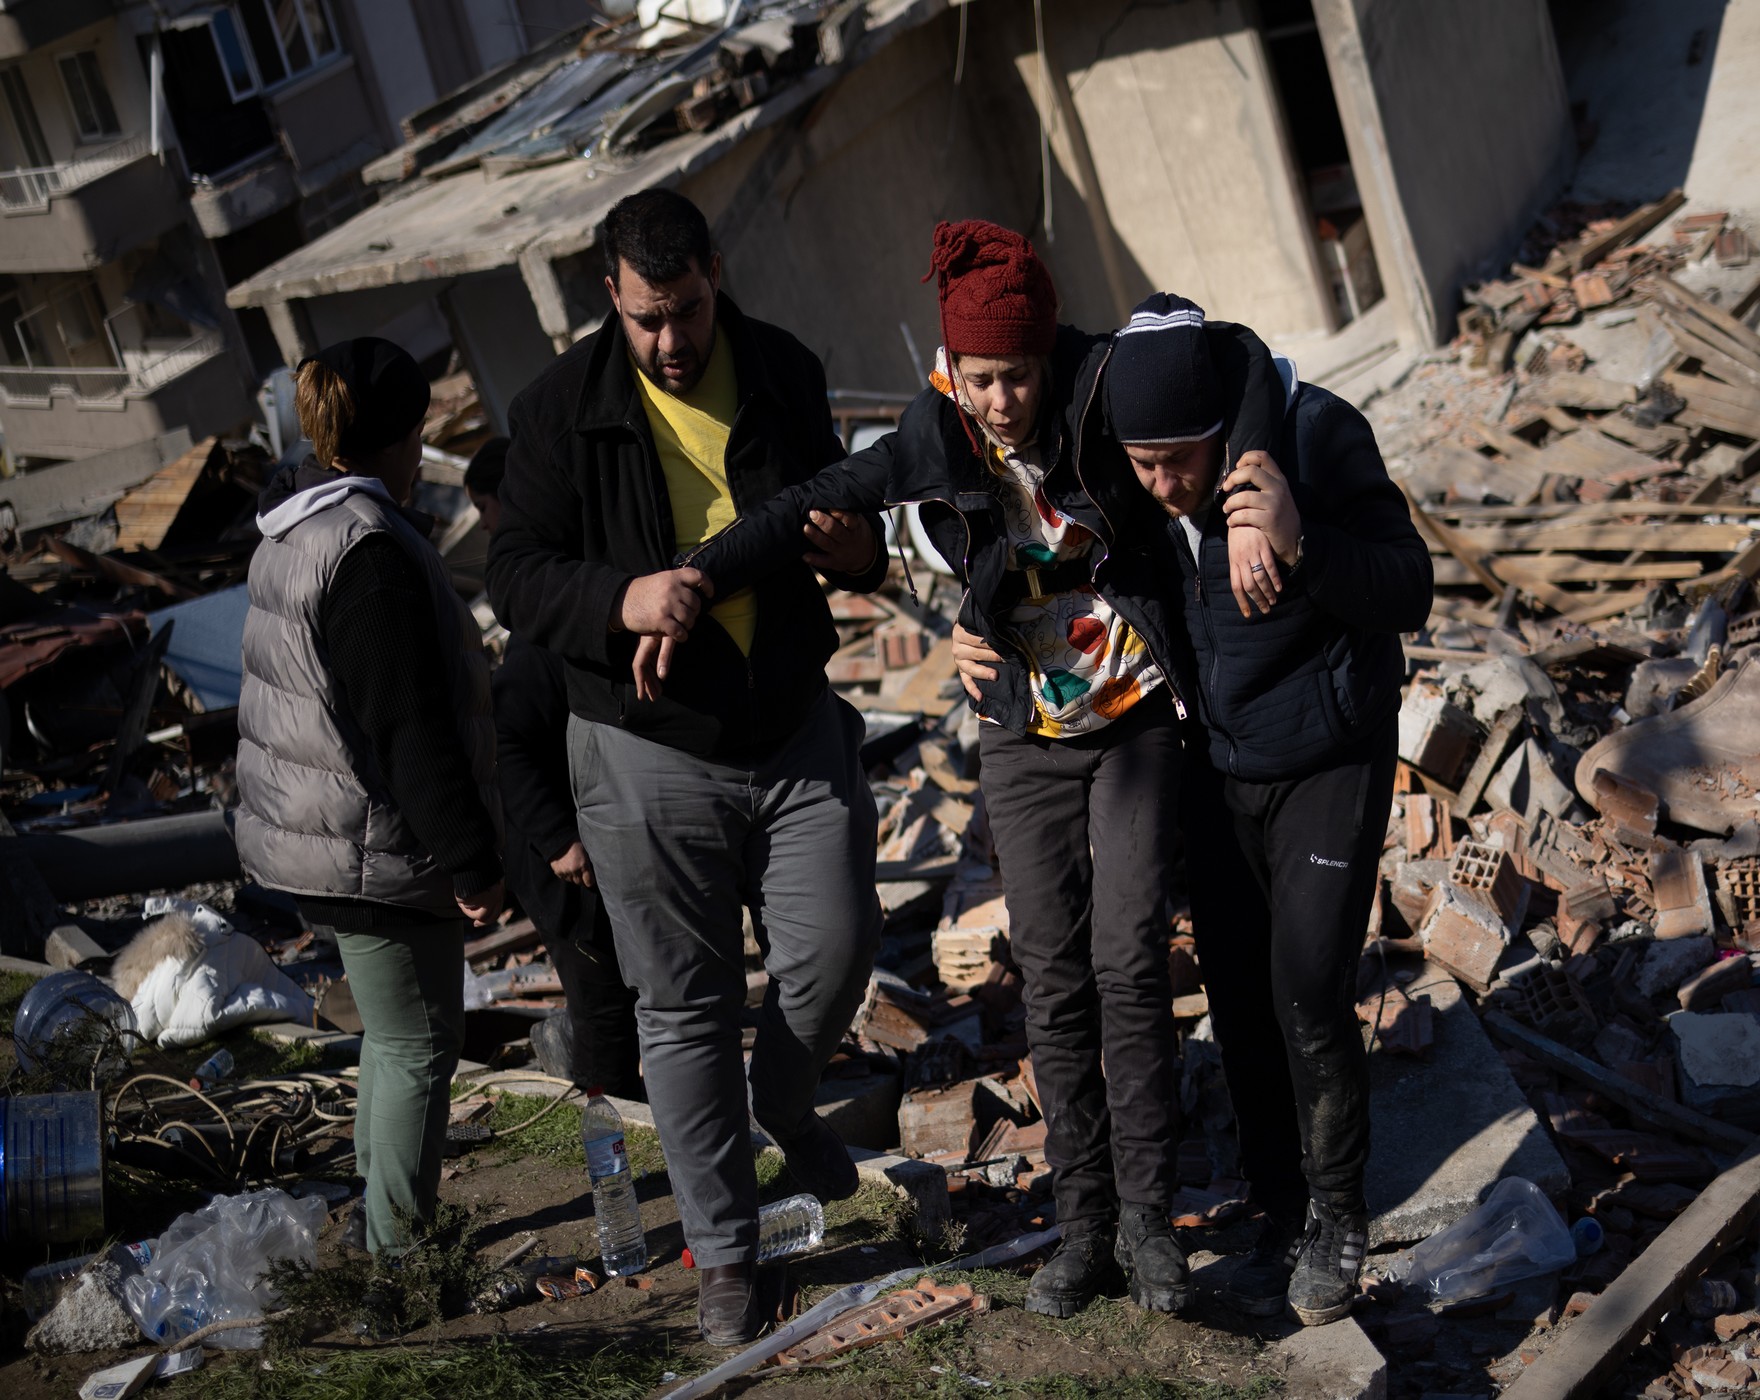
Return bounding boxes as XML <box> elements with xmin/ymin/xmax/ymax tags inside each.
<box><xmin>489</xmin><ymin>190</ymin><xmax>885</xmax><ymax>1345</ymax></box>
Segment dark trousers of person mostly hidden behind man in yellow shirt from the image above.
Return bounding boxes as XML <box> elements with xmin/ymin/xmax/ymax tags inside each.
<box><xmin>539</xmin><ymin>889</ymin><xmax>646</xmax><ymax>1099</ymax></box>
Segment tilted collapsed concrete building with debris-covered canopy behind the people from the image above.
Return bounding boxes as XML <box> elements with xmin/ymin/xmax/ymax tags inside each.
<box><xmin>229</xmin><ymin>0</ymin><xmax>1573</xmax><ymax>433</ymax></box>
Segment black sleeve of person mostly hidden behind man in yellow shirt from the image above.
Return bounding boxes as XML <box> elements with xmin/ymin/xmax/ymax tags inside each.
<box><xmin>495</xmin><ymin>637</ymin><xmax>581</xmax><ymax>861</ymax></box>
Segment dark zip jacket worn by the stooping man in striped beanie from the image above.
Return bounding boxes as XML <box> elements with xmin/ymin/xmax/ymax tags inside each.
<box><xmin>1168</xmin><ymin>384</ymin><xmax>1433</xmax><ymax>782</ymax></box>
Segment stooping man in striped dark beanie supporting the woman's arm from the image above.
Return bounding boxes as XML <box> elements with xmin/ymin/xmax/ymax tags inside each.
<box><xmin>1104</xmin><ymin>298</ymin><xmax>1431</xmax><ymax>1326</ymax></box>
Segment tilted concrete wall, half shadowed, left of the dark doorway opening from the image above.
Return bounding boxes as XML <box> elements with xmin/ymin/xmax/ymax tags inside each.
<box><xmin>681</xmin><ymin>0</ymin><xmax>1329</xmax><ymax>393</ymax></box>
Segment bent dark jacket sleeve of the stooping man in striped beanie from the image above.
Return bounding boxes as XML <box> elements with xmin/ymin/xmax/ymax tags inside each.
<box><xmin>1295</xmin><ymin>400</ymin><xmax>1434</xmax><ymax>632</ymax></box>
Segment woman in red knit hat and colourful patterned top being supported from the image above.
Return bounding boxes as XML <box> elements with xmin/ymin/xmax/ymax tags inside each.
<box><xmin>637</xmin><ymin>220</ymin><xmax>1283</xmax><ymax>1317</ymax></box>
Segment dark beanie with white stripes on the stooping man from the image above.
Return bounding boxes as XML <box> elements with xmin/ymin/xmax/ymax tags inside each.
<box><xmin>1105</xmin><ymin>292</ymin><xmax>1221</xmax><ymax>444</ymax></box>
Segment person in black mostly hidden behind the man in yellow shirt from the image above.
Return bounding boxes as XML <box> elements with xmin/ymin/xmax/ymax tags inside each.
<box><xmin>465</xmin><ymin>437</ymin><xmax>642</xmax><ymax>1099</ymax></box>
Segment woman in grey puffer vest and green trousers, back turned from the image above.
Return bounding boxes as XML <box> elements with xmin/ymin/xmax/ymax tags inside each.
<box><xmin>238</xmin><ymin>338</ymin><xmax>502</xmax><ymax>1254</ymax></box>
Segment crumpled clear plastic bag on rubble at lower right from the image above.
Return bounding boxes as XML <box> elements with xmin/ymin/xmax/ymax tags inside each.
<box><xmin>1403</xmin><ymin>1176</ymin><xmax>1577</xmax><ymax>1303</ymax></box>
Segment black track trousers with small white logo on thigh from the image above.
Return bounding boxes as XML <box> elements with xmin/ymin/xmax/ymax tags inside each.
<box><xmin>1181</xmin><ymin>720</ymin><xmax>1397</xmax><ymax>1217</ymax></box>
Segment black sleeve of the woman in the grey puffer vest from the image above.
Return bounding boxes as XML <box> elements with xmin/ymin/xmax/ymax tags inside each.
<box><xmin>319</xmin><ymin>534</ymin><xmax>502</xmax><ymax>896</ymax></box>
